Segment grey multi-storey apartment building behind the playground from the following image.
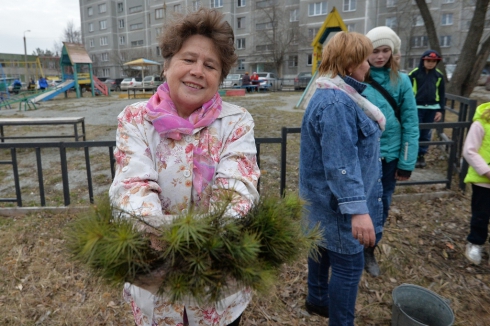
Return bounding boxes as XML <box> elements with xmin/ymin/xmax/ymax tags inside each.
<box><xmin>79</xmin><ymin>0</ymin><xmax>490</xmax><ymax>78</ymax></box>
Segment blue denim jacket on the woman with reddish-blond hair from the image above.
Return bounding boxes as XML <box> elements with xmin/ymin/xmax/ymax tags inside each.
<box><xmin>299</xmin><ymin>77</ymin><xmax>383</xmax><ymax>254</ymax></box>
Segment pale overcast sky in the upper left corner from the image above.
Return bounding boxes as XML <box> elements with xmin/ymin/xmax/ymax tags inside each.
<box><xmin>0</xmin><ymin>0</ymin><xmax>80</xmax><ymax>54</ymax></box>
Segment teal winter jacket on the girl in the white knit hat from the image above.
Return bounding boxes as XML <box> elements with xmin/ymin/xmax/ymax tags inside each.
<box><xmin>362</xmin><ymin>67</ymin><xmax>419</xmax><ymax>171</ymax></box>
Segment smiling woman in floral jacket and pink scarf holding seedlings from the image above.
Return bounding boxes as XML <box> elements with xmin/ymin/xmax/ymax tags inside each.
<box><xmin>109</xmin><ymin>8</ymin><xmax>260</xmax><ymax>326</ymax></box>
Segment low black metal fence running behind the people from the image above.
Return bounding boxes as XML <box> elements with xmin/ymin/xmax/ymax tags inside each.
<box><xmin>0</xmin><ymin>94</ymin><xmax>476</xmax><ymax>207</ymax></box>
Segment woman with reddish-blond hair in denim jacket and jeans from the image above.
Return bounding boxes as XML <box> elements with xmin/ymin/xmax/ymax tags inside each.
<box><xmin>299</xmin><ymin>32</ymin><xmax>386</xmax><ymax>325</ymax></box>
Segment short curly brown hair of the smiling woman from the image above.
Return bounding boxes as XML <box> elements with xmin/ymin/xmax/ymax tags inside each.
<box><xmin>159</xmin><ymin>8</ymin><xmax>238</xmax><ymax>82</ymax></box>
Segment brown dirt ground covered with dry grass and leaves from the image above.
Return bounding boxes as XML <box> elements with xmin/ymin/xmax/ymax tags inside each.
<box><xmin>0</xmin><ymin>89</ymin><xmax>490</xmax><ymax>326</ymax></box>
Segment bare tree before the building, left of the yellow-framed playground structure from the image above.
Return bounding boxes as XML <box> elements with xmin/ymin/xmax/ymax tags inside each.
<box><xmin>256</xmin><ymin>0</ymin><xmax>299</xmax><ymax>77</ymax></box>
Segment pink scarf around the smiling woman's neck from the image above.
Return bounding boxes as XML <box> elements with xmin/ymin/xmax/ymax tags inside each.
<box><xmin>146</xmin><ymin>83</ymin><xmax>222</xmax><ymax>197</ymax></box>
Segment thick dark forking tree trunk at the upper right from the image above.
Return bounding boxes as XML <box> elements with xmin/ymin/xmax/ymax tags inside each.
<box><xmin>415</xmin><ymin>0</ymin><xmax>490</xmax><ymax>96</ymax></box>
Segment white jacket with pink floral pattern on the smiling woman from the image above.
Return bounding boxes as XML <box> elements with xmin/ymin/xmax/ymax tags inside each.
<box><xmin>109</xmin><ymin>102</ymin><xmax>260</xmax><ymax>326</ymax></box>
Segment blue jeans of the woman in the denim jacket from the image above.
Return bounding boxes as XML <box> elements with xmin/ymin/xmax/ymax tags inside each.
<box><xmin>306</xmin><ymin>248</ymin><xmax>364</xmax><ymax>326</ymax></box>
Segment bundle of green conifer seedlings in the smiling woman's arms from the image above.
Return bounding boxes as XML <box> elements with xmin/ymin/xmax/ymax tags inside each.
<box><xmin>67</xmin><ymin>194</ymin><xmax>322</xmax><ymax>304</ymax></box>
